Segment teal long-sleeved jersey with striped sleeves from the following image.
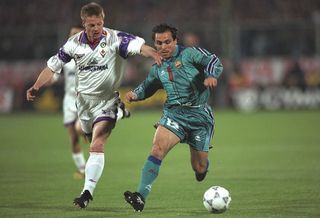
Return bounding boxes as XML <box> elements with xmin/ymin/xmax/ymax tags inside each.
<box><xmin>134</xmin><ymin>45</ymin><xmax>223</xmax><ymax>107</ymax></box>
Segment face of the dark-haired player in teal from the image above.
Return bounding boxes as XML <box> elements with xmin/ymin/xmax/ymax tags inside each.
<box><xmin>154</xmin><ymin>31</ymin><xmax>177</xmax><ymax>59</ymax></box>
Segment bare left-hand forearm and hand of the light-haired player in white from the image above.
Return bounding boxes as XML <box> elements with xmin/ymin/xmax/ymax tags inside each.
<box><xmin>26</xmin><ymin>67</ymin><xmax>53</xmax><ymax>101</ymax></box>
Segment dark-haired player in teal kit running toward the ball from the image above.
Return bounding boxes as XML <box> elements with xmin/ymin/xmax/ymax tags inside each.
<box><xmin>124</xmin><ymin>24</ymin><xmax>223</xmax><ymax>211</ymax></box>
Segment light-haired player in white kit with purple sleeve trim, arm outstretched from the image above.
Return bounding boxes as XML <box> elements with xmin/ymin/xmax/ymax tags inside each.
<box><xmin>26</xmin><ymin>3</ymin><xmax>161</xmax><ymax>208</ymax></box>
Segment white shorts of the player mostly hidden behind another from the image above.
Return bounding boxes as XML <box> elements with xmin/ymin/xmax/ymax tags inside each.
<box><xmin>63</xmin><ymin>93</ymin><xmax>78</xmax><ymax>127</ymax></box>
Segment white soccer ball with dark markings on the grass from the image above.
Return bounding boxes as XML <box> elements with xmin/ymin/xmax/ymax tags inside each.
<box><xmin>203</xmin><ymin>186</ymin><xmax>231</xmax><ymax>213</ymax></box>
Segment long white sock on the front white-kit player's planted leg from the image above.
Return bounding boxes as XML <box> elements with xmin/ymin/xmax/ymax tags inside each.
<box><xmin>82</xmin><ymin>152</ymin><xmax>104</xmax><ymax>195</ymax></box>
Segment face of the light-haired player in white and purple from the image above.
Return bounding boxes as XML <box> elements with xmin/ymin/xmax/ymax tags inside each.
<box><xmin>83</xmin><ymin>15</ymin><xmax>104</xmax><ymax>42</ymax></box>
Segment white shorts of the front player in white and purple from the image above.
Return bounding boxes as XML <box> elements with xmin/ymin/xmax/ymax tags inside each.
<box><xmin>76</xmin><ymin>91</ymin><xmax>121</xmax><ymax>134</ymax></box>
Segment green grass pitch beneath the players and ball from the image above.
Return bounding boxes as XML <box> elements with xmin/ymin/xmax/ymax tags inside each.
<box><xmin>0</xmin><ymin>111</ymin><xmax>320</xmax><ymax>218</ymax></box>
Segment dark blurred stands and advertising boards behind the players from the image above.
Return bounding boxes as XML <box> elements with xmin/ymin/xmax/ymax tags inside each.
<box><xmin>0</xmin><ymin>0</ymin><xmax>320</xmax><ymax>113</ymax></box>
